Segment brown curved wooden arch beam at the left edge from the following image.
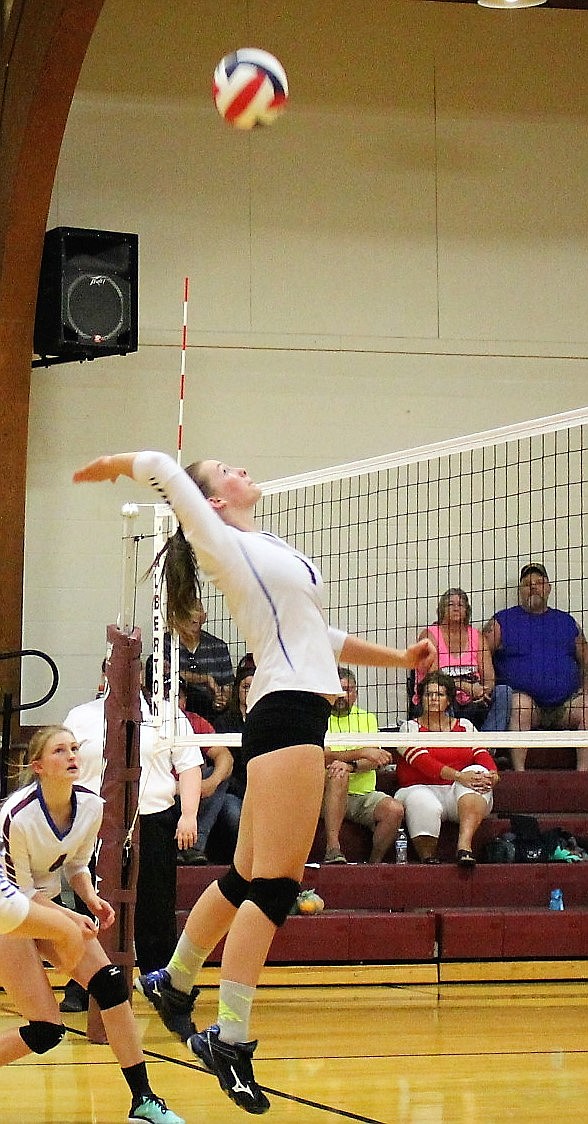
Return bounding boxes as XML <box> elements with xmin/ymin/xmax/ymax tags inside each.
<box><xmin>0</xmin><ymin>0</ymin><xmax>105</xmax><ymax>719</ymax></box>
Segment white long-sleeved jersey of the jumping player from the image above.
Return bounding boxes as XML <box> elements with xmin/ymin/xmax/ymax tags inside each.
<box><xmin>133</xmin><ymin>452</ymin><xmax>346</xmax><ymax>710</ymax></box>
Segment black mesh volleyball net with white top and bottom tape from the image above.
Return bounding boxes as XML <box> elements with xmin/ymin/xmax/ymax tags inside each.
<box><xmin>115</xmin><ymin>408</ymin><xmax>588</xmax><ymax>746</ymax></box>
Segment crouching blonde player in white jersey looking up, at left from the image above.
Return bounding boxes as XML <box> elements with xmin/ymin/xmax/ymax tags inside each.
<box><xmin>0</xmin><ymin>726</ymin><xmax>184</xmax><ymax>1124</ymax></box>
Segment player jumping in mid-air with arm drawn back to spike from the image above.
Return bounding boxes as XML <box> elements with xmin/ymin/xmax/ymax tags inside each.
<box><xmin>74</xmin><ymin>452</ymin><xmax>434</xmax><ymax>1114</ymax></box>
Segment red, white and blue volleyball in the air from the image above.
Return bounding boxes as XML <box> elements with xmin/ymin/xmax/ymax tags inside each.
<box><xmin>212</xmin><ymin>47</ymin><xmax>288</xmax><ymax>129</ymax></box>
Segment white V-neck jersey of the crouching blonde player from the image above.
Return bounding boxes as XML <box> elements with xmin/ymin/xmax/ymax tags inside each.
<box><xmin>0</xmin><ymin>782</ymin><xmax>103</xmax><ymax>898</ymax></box>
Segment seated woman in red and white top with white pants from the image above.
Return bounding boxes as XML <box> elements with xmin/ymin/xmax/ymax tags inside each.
<box><xmin>393</xmin><ymin>671</ymin><xmax>498</xmax><ymax>867</ymax></box>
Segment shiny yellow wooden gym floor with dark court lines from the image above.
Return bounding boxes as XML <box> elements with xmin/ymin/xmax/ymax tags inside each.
<box><xmin>0</xmin><ymin>966</ymin><xmax>588</xmax><ymax>1124</ymax></box>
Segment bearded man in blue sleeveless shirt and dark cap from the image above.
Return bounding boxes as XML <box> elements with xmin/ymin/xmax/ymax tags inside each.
<box><xmin>485</xmin><ymin>562</ymin><xmax>588</xmax><ymax>772</ymax></box>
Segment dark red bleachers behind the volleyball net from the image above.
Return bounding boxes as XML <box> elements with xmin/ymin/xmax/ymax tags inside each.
<box><xmin>178</xmin><ymin>769</ymin><xmax>588</xmax><ymax>964</ymax></box>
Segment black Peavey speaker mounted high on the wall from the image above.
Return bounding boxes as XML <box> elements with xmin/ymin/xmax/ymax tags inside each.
<box><xmin>34</xmin><ymin>226</ymin><xmax>138</xmax><ymax>361</ymax></box>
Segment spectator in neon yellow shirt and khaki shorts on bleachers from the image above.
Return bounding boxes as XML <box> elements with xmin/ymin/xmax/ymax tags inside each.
<box><xmin>323</xmin><ymin>668</ymin><xmax>404</xmax><ymax>863</ymax></box>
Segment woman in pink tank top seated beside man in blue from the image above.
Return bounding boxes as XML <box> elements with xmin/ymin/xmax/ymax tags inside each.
<box><xmin>410</xmin><ymin>588</ymin><xmax>512</xmax><ymax>731</ymax></box>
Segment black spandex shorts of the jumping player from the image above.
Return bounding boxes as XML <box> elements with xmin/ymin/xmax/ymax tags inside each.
<box><xmin>242</xmin><ymin>691</ymin><xmax>332</xmax><ymax>761</ymax></box>
